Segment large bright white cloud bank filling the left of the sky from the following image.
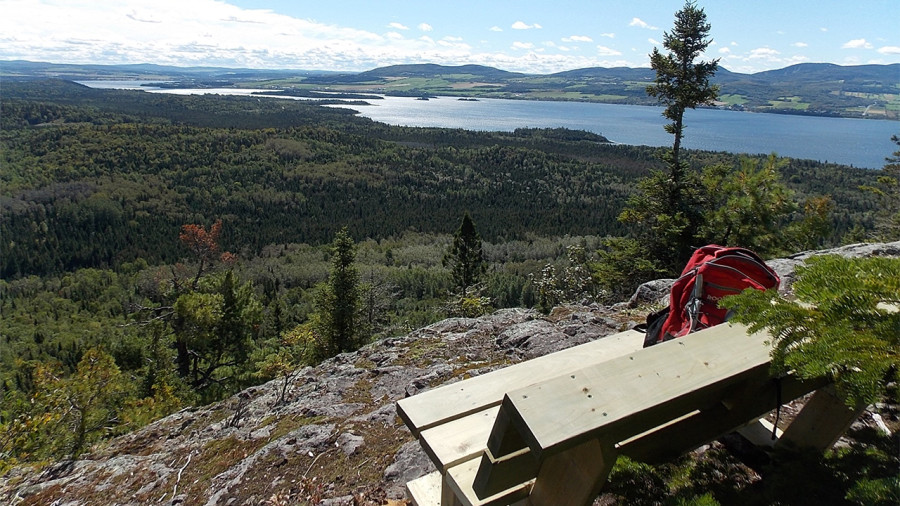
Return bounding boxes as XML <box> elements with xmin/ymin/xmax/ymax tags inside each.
<box><xmin>0</xmin><ymin>0</ymin><xmax>402</xmax><ymax>69</ymax></box>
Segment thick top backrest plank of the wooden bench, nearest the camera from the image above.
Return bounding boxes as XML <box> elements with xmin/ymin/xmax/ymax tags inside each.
<box><xmin>496</xmin><ymin>325</ymin><xmax>771</xmax><ymax>461</ymax></box>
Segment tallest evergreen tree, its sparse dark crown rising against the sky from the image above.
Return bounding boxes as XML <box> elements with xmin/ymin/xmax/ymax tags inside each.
<box><xmin>619</xmin><ymin>2</ymin><xmax>718</xmax><ymax>273</ymax></box>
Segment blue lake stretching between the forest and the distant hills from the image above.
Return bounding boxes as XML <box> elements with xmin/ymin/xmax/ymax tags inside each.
<box><xmin>80</xmin><ymin>81</ymin><xmax>900</xmax><ymax>169</ymax></box>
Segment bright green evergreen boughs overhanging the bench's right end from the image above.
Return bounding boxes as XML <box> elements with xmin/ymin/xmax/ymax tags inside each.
<box><xmin>722</xmin><ymin>255</ymin><xmax>900</xmax><ymax>406</ymax></box>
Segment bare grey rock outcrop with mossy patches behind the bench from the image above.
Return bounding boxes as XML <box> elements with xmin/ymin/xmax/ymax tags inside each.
<box><xmin>0</xmin><ymin>242</ymin><xmax>900</xmax><ymax>506</ymax></box>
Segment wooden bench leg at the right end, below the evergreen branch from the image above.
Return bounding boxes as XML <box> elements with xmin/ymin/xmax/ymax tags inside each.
<box><xmin>776</xmin><ymin>385</ymin><xmax>866</xmax><ymax>451</ymax></box>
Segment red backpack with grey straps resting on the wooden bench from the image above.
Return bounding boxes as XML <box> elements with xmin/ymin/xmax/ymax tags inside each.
<box><xmin>644</xmin><ymin>244</ymin><xmax>781</xmax><ymax>347</ymax></box>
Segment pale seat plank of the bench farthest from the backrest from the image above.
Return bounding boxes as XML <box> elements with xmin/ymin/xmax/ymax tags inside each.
<box><xmin>397</xmin><ymin>330</ymin><xmax>644</xmax><ymax>438</ymax></box>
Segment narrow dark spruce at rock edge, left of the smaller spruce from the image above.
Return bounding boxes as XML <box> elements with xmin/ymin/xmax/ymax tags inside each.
<box><xmin>313</xmin><ymin>227</ymin><xmax>361</xmax><ymax>358</ymax></box>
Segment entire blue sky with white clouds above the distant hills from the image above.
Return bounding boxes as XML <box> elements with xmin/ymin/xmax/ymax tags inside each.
<box><xmin>0</xmin><ymin>0</ymin><xmax>900</xmax><ymax>75</ymax></box>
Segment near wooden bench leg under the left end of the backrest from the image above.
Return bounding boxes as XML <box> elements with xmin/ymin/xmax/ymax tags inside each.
<box><xmin>528</xmin><ymin>439</ymin><xmax>616</xmax><ymax>506</ymax></box>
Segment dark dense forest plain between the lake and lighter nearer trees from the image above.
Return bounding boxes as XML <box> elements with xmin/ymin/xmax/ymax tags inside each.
<box><xmin>0</xmin><ymin>82</ymin><xmax>873</xmax><ymax>278</ymax></box>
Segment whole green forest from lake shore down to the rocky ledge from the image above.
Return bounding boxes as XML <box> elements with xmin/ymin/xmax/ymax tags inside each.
<box><xmin>0</xmin><ymin>81</ymin><xmax>889</xmax><ymax>472</ymax></box>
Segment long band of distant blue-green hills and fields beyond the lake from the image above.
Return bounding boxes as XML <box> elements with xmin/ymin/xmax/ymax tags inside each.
<box><xmin>0</xmin><ymin>61</ymin><xmax>900</xmax><ymax>119</ymax></box>
